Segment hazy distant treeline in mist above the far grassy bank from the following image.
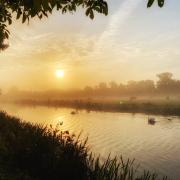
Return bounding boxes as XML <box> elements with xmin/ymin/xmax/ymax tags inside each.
<box><xmin>3</xmin><ymin>72</ymin><xmax>180</xmax><ymax>99</ymax></box>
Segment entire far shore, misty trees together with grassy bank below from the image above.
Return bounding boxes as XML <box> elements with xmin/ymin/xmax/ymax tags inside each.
<box><xmin>1</xmin><ymin>72</ymin><xmax>180</xmax><ymax>116</ymax></box>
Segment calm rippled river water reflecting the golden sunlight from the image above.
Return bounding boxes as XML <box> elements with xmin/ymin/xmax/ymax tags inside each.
<box><xmin>1</xmin><ymin>105</ymin><xmax>180</xmax><ymax>180</ymax></box>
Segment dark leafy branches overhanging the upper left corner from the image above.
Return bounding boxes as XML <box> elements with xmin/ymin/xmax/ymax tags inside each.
<box><xmin>0</xmin><ymin>0</ymin><xmax>108</xmax><ymax>50</ymax></box>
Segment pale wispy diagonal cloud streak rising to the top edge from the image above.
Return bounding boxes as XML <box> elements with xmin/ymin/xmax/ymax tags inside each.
<box><xmin>90</xmin><ymin>0</ymin><xmax>142</xmax><ymax>61</ymax></box>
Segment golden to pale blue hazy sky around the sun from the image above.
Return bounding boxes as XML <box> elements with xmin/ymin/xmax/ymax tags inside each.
<box><xmin>0</xmin><ymin>0</ymin><xmax>180</xmax><ymax>90</ymax></box>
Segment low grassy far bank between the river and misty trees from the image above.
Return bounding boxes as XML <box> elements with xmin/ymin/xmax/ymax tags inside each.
<box><xmin>15</xmin><ymin>100</ymin><xmax>180</xmax><ymax>116</ymax></box>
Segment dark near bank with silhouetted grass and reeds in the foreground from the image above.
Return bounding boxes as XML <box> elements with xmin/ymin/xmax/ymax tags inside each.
<box><xmin>0</xmin><ymin>112</ymin><xmax>167</xmax><ymax>180</ymax></box>
